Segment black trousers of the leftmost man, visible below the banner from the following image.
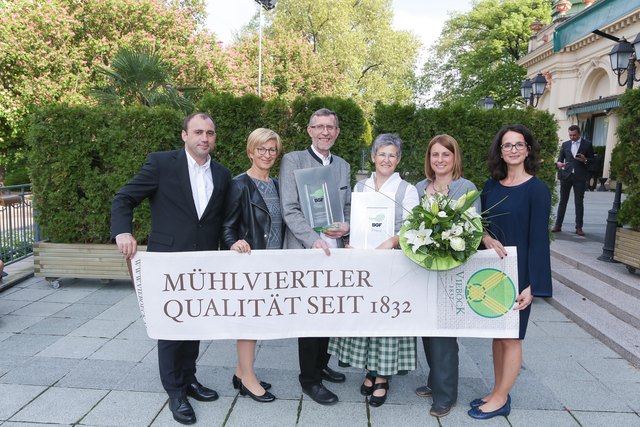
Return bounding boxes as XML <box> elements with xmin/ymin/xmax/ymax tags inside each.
<box><xmin>158</xmin><ymin>340</ymin><xmax>200</xmax><ymax>398</ymax></box>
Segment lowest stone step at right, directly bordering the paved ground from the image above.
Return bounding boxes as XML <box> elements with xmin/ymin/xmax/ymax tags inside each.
<box><xmin>545</xmin><ymin>279</ymin><xmax>640</xmax><ymax>368</ymax></box>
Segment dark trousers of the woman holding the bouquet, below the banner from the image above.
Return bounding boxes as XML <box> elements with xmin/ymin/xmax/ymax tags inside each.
<box><xmin>422</xmin><ymin>337</ymin><xmax>459</xmax><ymax>407</ymax></box>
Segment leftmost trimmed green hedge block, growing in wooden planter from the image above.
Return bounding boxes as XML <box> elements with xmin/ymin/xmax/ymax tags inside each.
<box><xmin>27</xmin><ymin>105</ymin><xmax>183</xmax><ymax>243</ymax></box>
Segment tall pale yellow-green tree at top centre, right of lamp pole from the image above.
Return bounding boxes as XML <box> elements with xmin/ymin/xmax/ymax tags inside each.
<box><xmin>270</xmin><ymin>0</ymin><xmax>420</xmax><ymax>113</ymax></box>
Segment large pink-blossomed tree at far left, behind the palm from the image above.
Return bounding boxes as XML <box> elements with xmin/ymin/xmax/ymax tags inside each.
<box><xmin>0</xmin><ymin>0</ymin><xmax>224</xmax><ymax>181</ymax></box>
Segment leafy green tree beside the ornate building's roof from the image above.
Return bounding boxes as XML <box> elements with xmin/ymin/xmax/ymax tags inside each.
<box><xmin>417</xmin><ymin>0</ymin><xmax>551</xmax><ymax>107</ymax></box>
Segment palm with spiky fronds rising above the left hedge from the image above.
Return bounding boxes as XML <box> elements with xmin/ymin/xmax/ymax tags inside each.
<box><xmin>90</xmin><ymin>49</ymin><xmax>193</xmax><ymax>114</ymax></box>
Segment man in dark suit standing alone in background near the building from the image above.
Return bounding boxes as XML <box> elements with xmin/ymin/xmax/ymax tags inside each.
<box><xmin>551</xmin><ymin>125</ymin><xmax>593</xmax><ymax>236</ymax></box>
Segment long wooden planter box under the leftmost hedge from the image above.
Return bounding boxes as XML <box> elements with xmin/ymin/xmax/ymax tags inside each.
<box><xmin>33</xmin><ymin>242</ymin><xmax>146</xmax><ymax>288</ymax></box>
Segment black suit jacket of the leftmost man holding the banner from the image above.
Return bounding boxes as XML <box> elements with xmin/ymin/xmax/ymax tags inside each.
<box><xmin>111</xmin><ymin>149</ymin><xmax>231</xmax><ymax>252</ymax></box>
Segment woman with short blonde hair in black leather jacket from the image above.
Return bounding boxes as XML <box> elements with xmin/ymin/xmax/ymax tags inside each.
<box><xmin>222</xmin><ymin>128</ymin><xmax>284</xmax><ymax>402</ymax></box>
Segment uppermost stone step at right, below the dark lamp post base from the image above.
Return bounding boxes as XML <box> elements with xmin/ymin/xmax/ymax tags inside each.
<box><xmin>551</xmin><ymin>247</ymin><xmax>640</xmax><ymax>298</ymax></box>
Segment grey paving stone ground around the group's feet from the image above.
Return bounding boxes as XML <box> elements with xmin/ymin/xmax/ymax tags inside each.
<box><xmin>0</xmin><ymin>193</ymin><xmax>640</xmax><ymax>427</ymax></box>
